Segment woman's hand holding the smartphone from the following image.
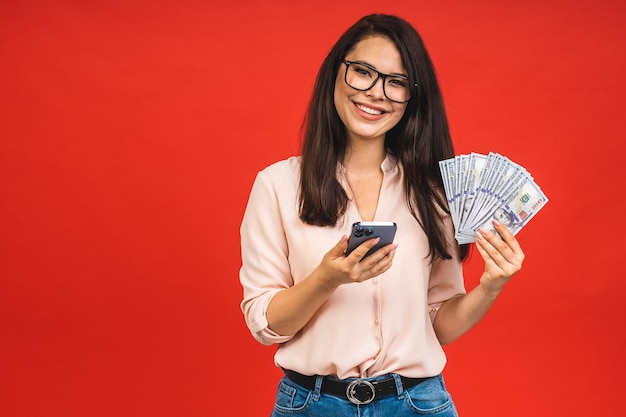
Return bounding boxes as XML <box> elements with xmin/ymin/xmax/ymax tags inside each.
<box><xmin>317</xmin><ymin>236</ymin><xmax>398</xmax><ymax>288</ymax></box>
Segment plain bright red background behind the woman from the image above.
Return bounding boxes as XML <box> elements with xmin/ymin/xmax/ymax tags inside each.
<box><xmin>0</xmin><ymin>0</ymin><xmax>626</xmax><ymax>417</ymax></box>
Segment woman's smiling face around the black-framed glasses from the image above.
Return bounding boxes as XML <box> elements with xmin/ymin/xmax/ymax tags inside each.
<box><xmin>334</xmin><ymin>36</ymin><xmax>407</xmax><ymax>146</ymax></box>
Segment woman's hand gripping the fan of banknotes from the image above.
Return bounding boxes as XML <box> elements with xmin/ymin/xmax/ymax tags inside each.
<box><xmin>476</xmin><ymin>220</ymin><xmax>525</xmax><ymax>295</ymax></box>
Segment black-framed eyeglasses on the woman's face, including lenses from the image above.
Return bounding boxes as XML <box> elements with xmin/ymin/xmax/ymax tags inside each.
<box><xmin>343</xmin><ymin>59</ymin><xmax>417</xmax><ymax>103</ymax></box>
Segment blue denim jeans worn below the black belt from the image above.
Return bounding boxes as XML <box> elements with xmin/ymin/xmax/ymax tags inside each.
<box><xmin>271</xmin><ymin>374</ymin><xmax>458</xmax><ymax>417</ymax></box>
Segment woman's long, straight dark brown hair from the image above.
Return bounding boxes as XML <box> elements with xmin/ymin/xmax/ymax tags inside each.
<box><xmin>300</xmin><ymin>14</ymin><xmax>468</xmax><ymax>259</ymax></box>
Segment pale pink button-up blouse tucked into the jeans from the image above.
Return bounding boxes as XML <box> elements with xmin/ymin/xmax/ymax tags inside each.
<box><xmin>240</xmin><ymin>156</ymin><xmax>465</xmax><ymax>378</ymax></box>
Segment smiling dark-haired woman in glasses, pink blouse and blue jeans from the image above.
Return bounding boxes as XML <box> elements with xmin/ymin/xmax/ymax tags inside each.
<box><xmin>240</xmin><ymin>15</ymin><xmax>524</xmax><ymax>417</ymax></box>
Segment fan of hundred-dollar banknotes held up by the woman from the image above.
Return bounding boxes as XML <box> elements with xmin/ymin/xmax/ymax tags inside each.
<box><xmin>439</xmin><ymin>152</ymin><xmax>548</xmax><ymax>244</ymax></box>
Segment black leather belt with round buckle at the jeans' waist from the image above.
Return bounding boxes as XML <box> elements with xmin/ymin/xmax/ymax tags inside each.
<box><xmin>285</xmin><ymin>370</ymin><xmax>428</xmax><ymax>404</ymax></box>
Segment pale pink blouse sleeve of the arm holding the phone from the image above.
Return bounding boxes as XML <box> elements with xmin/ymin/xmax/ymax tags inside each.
<box><xmin>239</xmin><ymin>171</ymin><xmax>293</xmax><ymax>345</ymax></box>
